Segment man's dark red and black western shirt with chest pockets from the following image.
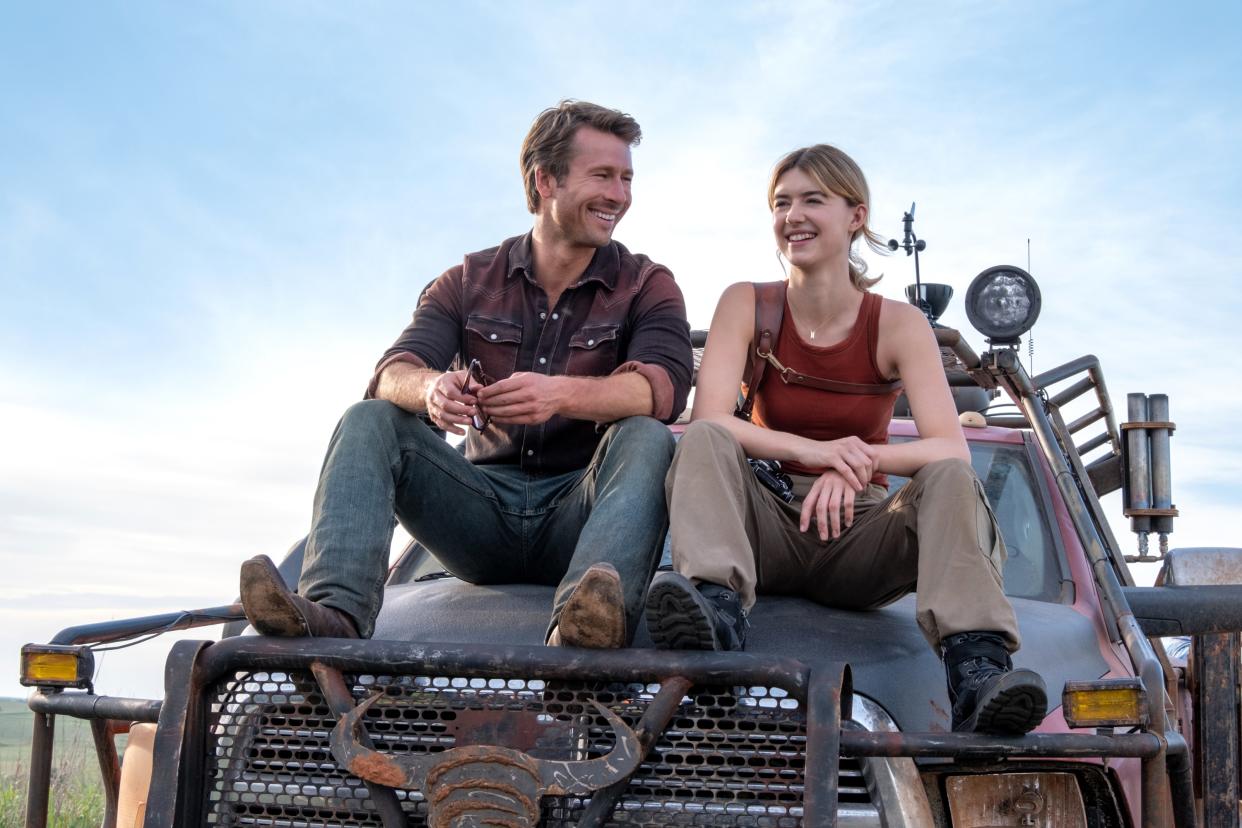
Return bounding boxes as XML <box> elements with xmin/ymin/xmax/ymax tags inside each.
<box><xmin>366</xmin><ymin>233</ymin><xmax>693</xmax><ymax>473</ymax></box>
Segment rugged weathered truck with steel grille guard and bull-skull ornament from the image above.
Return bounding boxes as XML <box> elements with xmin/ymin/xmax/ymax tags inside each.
<box><xmin>21</xmin><ymin>266</ymin><xmax>1242</xmax><ymax>828</ymax></box>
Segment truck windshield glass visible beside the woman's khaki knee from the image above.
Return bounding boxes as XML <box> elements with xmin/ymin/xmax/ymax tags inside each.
<box><xmin>888</xmin><ymin>438</ymin><xmax>1061</xmax><ymax>601</ymax></box>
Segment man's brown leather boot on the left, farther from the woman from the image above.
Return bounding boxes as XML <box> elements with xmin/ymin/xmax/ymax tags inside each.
<box><xmin>241</xmin><ymin>555</ymin><xmax>358</xmax><ymax>638</ymax></box>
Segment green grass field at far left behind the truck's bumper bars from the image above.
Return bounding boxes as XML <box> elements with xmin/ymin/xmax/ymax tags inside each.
<box><xmin>0</xmin><ymin>699</ymin><xmax>103</xmax><ymax>828</ymax></box>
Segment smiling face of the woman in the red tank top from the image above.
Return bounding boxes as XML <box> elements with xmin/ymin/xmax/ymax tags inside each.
<box><xmin>773</xmin><ymin>168</ymin><xmax>867</xmax><ymax>268</ymax></box>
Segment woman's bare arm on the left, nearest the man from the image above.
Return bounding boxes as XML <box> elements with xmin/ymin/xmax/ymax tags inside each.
<box><xmin>691</xmin><ymin>282</ymin><xmax>879</xmax><ymax>490</ymax></box>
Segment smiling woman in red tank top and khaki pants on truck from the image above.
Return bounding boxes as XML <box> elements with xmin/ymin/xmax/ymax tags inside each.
<box><xmin>647</xmin><ymin>144</ymin><xmax>1046</xmax><ymax>734</ymax></box>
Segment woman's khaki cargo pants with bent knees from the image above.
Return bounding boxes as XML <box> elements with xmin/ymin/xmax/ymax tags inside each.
<box><xmin>664</xmin><ymin>421</ymin><xmax>1020</xmax><ymax>652</ymax></box>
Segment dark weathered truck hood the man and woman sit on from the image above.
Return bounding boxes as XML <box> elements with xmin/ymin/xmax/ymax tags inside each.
<box><xmin>374</xmin><ymin>577</ymin><xmax>1108</xmax><ymax>732</ymax></box>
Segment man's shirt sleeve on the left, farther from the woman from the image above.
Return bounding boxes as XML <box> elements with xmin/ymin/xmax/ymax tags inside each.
<box><xmin>365</xmin><ymin>266</ymin><xmax>462</xmax><ymax>400</ymax></box>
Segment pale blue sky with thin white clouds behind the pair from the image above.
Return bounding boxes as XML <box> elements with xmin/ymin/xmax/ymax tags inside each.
<box><xmin>0</xmin><ymin>1</ymin><xmax>1242</xmax><ymax>695</ymax></box>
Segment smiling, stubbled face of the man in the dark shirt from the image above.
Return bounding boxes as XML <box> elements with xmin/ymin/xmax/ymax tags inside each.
<box><xmin>540</xmin><ymin>127</ymin><xmax>633</xmax><ymax>247</ymax></box>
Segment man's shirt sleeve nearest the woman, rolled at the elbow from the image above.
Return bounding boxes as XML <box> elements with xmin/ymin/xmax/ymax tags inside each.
<box><xmin>614</xmin><ymin>267</ymin><xmax>694</xmax><ymax>423</ymax></box>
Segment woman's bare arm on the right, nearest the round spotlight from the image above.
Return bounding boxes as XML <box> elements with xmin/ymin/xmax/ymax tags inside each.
<box><xmin>876</xmin><ymin>299</ymin><xmax>970</xmax><ymax>477</ymax></box>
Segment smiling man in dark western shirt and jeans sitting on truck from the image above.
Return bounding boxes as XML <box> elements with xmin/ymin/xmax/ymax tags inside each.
<box><xmin>241</xmin><ymin>101</ymin><xmax>692</xmax><ymax>647</ymax></box>
